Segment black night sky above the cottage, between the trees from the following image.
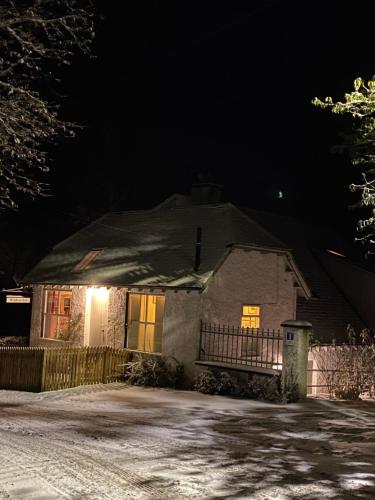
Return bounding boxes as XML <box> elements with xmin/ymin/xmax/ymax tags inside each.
<box><xmin>2</xmin><ymin>0</ymin><xmax>375</xmax><ymax>274</ymax></box>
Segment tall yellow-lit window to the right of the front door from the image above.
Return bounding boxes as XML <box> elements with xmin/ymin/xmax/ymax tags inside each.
<box><xmin>127</xmin><ymin>293</ymin><xmax>165</xmax><ymax>352</ymax></box>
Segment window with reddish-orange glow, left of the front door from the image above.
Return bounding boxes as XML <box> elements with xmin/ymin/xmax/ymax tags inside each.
<box><xmin>42</xmin><ymin>290</ymin><xmax>72</xmax><ymax>339</ymax></box>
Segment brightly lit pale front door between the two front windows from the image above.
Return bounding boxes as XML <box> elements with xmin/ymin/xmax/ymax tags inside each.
<box><xmin>89</xmin><ymin>288</ymin><xmax>108</xmax><ymax>346</ymax></box>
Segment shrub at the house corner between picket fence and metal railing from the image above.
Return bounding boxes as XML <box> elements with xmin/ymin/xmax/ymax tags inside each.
<box><xmin>126</xmin><ymin>355</ymin><xmax>184</xmax><ymax>388</ymax></box>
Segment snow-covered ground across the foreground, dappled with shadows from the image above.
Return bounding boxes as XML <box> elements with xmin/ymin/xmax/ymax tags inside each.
<box><xmin>0</xmin><ymin>384</ymin><xmax>375</xmax><ymax>500</ymax></box>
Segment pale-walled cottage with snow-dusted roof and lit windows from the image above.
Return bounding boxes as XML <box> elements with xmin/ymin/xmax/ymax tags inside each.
<box><xmin>25</xmin><ymin>186</ymin><xmax>311</xmax><ymax>377</ymax></box>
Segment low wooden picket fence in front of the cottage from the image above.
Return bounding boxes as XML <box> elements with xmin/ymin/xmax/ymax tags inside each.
<box><xmin>0</xmin><ymin>347</ymin><xmax>131</xmax><ymax>392</ymax></box>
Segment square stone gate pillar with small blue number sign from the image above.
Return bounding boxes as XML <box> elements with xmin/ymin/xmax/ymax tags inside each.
<box><xmin>281</xmin><ymin>320</ymin><xmax>312</xmax><ymax>398</ymax></box>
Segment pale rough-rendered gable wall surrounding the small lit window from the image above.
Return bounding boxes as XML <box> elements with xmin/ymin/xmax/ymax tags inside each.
<box><xmin>202</xmin><ymin>248</ymin><xmax>296</xmax><ymax>329</ymax></box>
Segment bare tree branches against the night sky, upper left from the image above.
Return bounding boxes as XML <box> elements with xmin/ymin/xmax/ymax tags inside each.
<box><xmin>0</xmin><ymin>0</ymin><xmax>94</xmax><ymax>208</ymax></box>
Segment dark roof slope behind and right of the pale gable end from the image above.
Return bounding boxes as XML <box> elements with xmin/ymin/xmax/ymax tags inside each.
<box><xmin>244</xmin><ymin>209</ymin><xmax>368</xmax><ymax>342</ymax></box>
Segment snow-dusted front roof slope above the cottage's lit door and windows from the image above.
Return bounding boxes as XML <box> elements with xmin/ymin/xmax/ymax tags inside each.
<box><xmin>25</xmin><ymin>202</ymin><xmax>284</xmax><ymax>287</ymax></box>
